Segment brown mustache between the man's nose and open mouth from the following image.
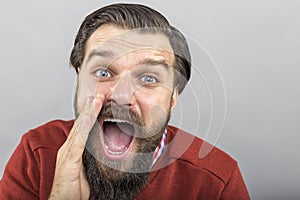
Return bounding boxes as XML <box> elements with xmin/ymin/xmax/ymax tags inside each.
<box><xmin>98</xmin><ymin>104</ymin><xmax>145</xmax><ymax>126</ymax></box>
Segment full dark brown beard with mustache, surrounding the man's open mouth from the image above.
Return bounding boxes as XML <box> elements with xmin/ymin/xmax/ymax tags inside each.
<box><xmin>75</xmin><ymin>91</ymin><xmax>171</xmax><ymax>200</ymax></box>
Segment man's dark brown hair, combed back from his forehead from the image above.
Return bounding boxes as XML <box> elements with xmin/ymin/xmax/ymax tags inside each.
<box><xmin>70</xmin><ymin>3</ymin><xmax>191</xmax><ymax>93</ymax></box>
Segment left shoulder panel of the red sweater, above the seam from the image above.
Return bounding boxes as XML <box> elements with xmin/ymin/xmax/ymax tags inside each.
<box><xmin>22</xmin><ymin>120</ymin><xmax>74</xmax><ymax>151</ymax></box>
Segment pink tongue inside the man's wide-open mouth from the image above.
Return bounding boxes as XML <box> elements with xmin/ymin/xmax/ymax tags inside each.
<box><xmin>104</xmin><ymin>123</ymin><xmax>132</xmax><ymax>152</ymax></box>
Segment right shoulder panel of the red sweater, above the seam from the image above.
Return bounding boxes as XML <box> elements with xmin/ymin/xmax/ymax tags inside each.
<box><xmin>168</xmin><ymin>126</ymin><xmax>238</xmax><ymax>183</ymax></box>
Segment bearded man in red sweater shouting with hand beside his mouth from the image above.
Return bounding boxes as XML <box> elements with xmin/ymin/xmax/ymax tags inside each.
<box><xmin>0</xmin><ymin>4</ymin><xmax>249</xmax><ymax>199</ymax></box>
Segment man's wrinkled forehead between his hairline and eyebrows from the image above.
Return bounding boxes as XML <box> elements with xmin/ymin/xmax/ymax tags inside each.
<box><xmin>84</xmin><ymin>25</ymin><xmax>174</xmax><ymax>66</ymax></box>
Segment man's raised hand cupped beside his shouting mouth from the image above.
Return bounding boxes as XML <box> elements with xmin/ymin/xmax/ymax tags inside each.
<box><xmin>49</xmin><ymin>95</ymin><xmax>104</xmax><ymax>200</ymax></box>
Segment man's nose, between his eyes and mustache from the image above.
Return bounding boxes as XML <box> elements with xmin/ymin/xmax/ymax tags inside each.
<box><xmin>111</xmin><ymin>73</ymin><xmax>135</xmax><ymax>106</ymax></box>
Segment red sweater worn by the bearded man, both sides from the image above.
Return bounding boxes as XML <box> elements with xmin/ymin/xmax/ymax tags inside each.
<box><xmin>0</xmin><ymin>120</ymin><xmax>250</xmax><ymax>200</ymax></box>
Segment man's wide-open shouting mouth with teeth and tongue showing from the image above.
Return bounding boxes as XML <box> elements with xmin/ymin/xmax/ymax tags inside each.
<box><xmin>100</xmin><ymin>119</ymin><xmax>135</xmax><ymax>160</ymax></box>
